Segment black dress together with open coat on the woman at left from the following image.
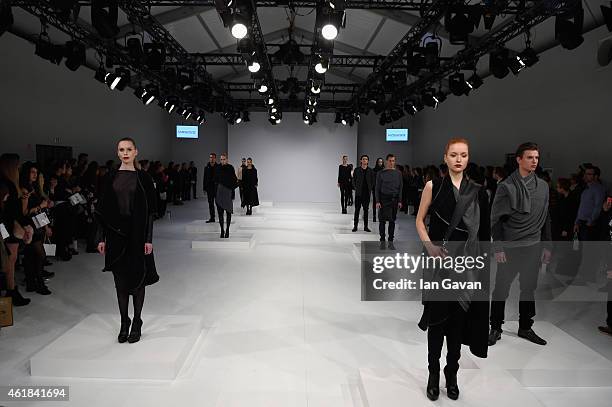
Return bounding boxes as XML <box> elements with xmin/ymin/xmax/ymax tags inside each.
<box><xmin>95</xmin><ymin>170</ymin><xmax>159</xmax><ymax>292</ymax></box>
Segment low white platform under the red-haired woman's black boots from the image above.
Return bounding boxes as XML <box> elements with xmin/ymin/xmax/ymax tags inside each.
<box><xmin>359</xmin><ymin>368</ymin><xmax>543</xmax><ymax>407</ymax></box>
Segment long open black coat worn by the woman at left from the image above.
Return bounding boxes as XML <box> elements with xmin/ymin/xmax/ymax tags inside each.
<box><xmin>95</xmin><ymin>170</ymin><xmax>159</xmax><ymax>288</ymax></box>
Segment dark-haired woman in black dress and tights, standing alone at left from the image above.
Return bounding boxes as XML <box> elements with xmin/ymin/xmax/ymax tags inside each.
<box><xmin>96</xmin><ymin>138</ymin><xmax>159</xmax><ymax>343</ymax></box>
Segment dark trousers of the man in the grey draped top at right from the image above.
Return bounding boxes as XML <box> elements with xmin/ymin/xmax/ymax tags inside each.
<box><xmin>490</xmin><ymin>244</ymin><xmax>542</xmax><ymax>329</ymax></box>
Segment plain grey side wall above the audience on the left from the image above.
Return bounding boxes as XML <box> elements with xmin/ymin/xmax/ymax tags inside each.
<box><xmin>0</xmin><ymin>33</ymin><xmax>172</xmax><ymax>163</ymax></box>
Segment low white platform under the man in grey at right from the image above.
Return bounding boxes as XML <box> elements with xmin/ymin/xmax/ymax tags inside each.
<box><xmin>474</xmin><ymin>320</ymin><xmax>612</xmax><ymax>387</ymax></box>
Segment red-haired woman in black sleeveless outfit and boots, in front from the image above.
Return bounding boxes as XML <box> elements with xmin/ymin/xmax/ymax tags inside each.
<box><xmin>416</xmin><ymin>139</ymin><xmax>491</xmax><ymax>400</ymax></box>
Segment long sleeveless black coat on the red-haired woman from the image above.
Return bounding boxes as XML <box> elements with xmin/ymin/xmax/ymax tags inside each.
<box><xmin>419</xmin><ymin>176</ymin><xmax>491</xmax><ymax>358</ymax></box>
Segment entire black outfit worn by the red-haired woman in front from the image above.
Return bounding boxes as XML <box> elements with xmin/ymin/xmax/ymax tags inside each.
<box><xmin>418</xmin><ymin>177</ymin><xmax>490</xmax><ymax>379</ymax></box>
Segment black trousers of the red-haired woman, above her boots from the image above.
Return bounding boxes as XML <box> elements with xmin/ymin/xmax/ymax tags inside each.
<box><xmin>427</xmin><ymin>305</ymin><xmax>465</xmax><ymax>375</ymax></box>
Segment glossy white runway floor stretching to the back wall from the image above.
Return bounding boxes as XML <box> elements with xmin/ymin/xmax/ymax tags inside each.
<box><xmin>0</xmin><ymin>198</ymin><xmax>612</xmax><ymax>407</ymax></box>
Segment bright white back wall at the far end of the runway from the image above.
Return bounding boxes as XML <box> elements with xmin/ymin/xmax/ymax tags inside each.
<box><xmin>228</xmin><ymin>113</ymin><xmax>357</xmax><ymax>202</ymax></box>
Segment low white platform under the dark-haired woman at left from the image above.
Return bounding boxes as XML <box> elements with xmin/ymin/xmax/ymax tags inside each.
<box><xmin>30</xmin><ymin>314</ymin><xmax>202</xmax><ymax>380</ymax></box>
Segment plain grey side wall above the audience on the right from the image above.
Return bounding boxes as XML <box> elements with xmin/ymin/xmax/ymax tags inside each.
<box><xmin>413</xmin><ymin>26</ymin><xmax>612</xmax><ymax>179</ymax></box>
